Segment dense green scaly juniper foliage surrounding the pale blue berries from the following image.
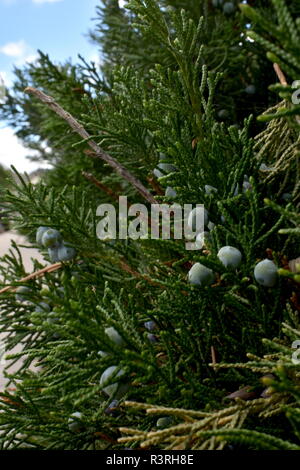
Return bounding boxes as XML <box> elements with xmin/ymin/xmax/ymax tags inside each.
<box><xmin>0</xmin><ymin>0</ymin><xmax>300</xmax><ymax>450</ymax></box>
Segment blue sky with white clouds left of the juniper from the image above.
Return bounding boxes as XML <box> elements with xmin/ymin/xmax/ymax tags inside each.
<box><xmin>0</xmin><ymin>0</ymin><xmax>107</xmax><ymax>171</ymax></box>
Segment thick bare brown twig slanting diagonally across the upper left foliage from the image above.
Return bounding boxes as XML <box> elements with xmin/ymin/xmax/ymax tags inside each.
<box><xmin>25</xmin><ymin>87</ymin><xmax>157</xmax><ymax>204</ymax></box>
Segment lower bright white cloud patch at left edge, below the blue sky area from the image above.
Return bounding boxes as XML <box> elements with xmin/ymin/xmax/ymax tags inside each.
<box><xmin>0</xmin><ymin>127</ymin><xmax>50</xmax><ymax>173</ymax></box>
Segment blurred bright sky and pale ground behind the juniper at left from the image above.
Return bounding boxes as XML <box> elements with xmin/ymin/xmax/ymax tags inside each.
<box><xmin>0</xmin><ymin>0</ymin><xmax>104</xmax><ymax>390</ymax></box>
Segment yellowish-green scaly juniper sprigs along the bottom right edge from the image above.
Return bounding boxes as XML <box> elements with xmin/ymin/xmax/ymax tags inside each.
<box><xmin>118</xmin><ymin>396</ymin><xmax>290</xmax><ymax>450</ymax></box>
